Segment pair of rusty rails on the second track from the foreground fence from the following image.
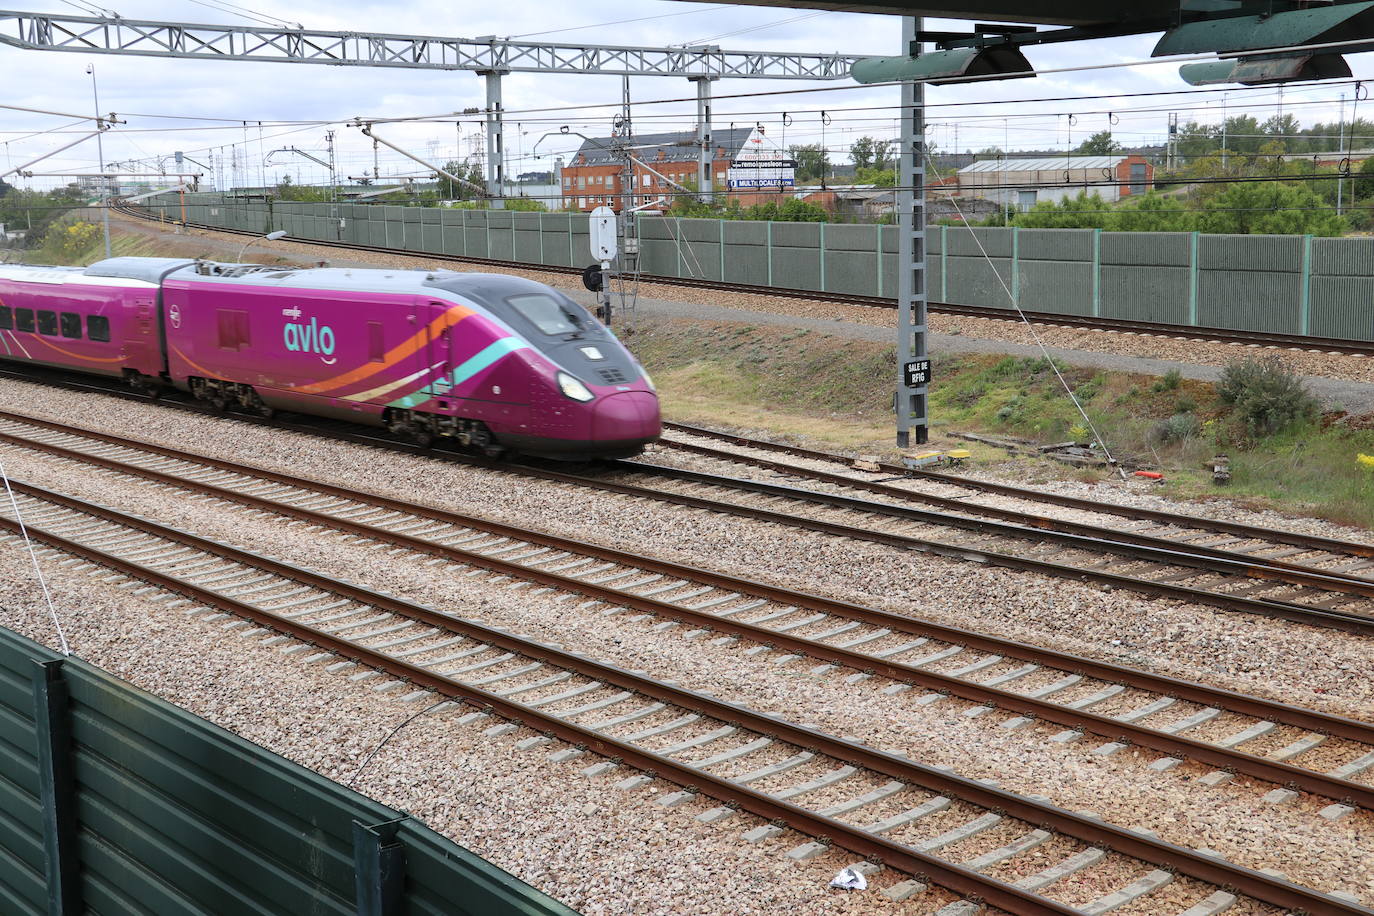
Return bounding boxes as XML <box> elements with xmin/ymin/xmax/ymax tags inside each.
<box><xmin>8</xmin><ymin>414</ymin><xmax>1374</xmax><ymax>810</ymax></box>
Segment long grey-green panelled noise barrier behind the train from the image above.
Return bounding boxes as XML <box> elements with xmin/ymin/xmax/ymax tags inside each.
<box><xmin>144</xmin><ymin>192</ymin><xmax>1374</xmax><ymax>341</ymax></box>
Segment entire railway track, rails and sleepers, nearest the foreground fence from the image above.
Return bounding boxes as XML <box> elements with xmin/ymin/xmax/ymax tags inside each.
<box><xmin>0</xmin><ymin>481</ymin><xmax>1374</xmax><ymax>916</ymax></box>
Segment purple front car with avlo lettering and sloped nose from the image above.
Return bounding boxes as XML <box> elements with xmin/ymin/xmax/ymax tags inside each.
<box><xmin>164</xmin><ymin>261</ymin><xmax>661</xmax><ymax>459</ymax></box>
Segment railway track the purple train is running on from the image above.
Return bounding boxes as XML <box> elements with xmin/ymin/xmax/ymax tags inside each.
<box><xmin>0</xmin><ymin>357</ymin><xmax>1374</xmax><ymax>634</ymax></box>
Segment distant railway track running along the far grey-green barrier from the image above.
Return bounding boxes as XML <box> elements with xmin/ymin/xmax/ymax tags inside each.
<box><xmin>115</xmin><ymin>206</ymin><xmax>1374</xmax><ymax>356</ymax></box>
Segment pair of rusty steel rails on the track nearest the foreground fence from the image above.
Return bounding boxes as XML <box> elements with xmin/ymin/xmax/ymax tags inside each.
<box><xmin>0</xmin><ymin>481</ymin><xmax>1374</xmax><ymax>916</ymax></box>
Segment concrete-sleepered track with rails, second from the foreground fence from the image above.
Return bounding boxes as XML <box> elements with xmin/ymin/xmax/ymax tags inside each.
<box><xmin>0</xmin><ymin>420</ymin><xmax>1374</xmax><ymax>817</ymax></box>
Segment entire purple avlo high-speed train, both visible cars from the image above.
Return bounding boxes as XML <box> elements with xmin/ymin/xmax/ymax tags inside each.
<box><xmin>0</xmin><ymin>258</ymin><xmax>661</xmax><ymax>460</ymax></box>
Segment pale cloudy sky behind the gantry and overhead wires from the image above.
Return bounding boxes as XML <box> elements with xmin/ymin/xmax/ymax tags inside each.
<box><xmin>0</xmin><ymin>0</ymin><xmax>1374</xmax><ymax>187</ymax></box>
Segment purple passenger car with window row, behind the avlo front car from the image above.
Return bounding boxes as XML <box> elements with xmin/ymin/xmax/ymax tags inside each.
<box><xmin>0</xmin><ymin>258</ymin><xmax>191</xmax><ymax>385</ymax></box>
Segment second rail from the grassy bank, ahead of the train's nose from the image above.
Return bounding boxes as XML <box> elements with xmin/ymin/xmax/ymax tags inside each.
<box><xmin>661</xmin><ymin>441</ymin><xmax>1374</xmax><ymax>585</ymax></box>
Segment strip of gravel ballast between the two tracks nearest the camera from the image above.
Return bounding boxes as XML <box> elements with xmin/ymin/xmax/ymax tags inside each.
<box><xmin>7</xmin><ymin>403</ymin><xmax>1367</xmax><ymax>911</ymax></box>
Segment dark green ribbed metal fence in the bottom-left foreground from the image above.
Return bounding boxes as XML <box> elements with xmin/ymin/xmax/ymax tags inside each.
<box><xmin>0</xmin><ymin>629</ymin><xmax>576</xmax><ymax>916</ymax></box>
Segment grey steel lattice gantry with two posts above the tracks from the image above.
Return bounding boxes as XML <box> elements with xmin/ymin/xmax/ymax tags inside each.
<box><xmin>0</xmin><ymin>10</ymin><xmax>863</xmax><ymax>206</ymax></box>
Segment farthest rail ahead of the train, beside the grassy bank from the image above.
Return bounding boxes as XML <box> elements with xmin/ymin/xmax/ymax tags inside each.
<box><xmin>658</xmin><ymin>420</ymin><xmax>1374</xmax><ymax>558</ymax></box>
